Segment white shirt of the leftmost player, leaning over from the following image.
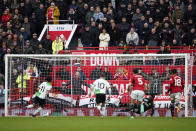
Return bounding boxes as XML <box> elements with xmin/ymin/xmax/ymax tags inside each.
<box><xmin>35</xmin><ymin>82</ymin><xmax>52</xmax><ymax>99</ymax></box>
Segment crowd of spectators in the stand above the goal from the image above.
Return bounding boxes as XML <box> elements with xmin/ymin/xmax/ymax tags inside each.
<box><xmin>0</xmin><ymin>0</ymin><xmax>196</xmax><ymax>88</ymax></box>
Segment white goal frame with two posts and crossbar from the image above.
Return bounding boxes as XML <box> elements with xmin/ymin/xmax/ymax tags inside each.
<box><xmin>5</xmin><ymin>53</ymin><xmax>192</xmax><ymax>117</ymax></box>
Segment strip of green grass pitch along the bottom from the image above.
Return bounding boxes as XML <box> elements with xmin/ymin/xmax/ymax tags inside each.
<box><xmin>0</xmin><ymin>117</ymin><xmax>196</xmax><ymax>131</ymax></box>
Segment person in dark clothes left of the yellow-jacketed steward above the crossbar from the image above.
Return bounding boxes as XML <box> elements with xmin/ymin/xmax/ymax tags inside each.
<box><xmin>41</xmin><ymin>34</ymin><xmax>52</xmax><ymax>54</ymax></box>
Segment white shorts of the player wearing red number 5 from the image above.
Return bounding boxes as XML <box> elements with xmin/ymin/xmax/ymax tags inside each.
<box><xmin>131</xmin><ymin>90</ymin><xmax>145</xmax><ymax>102</ymax></box>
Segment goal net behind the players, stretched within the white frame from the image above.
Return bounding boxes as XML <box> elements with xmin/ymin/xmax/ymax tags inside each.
<box><xmin>4</xmin><ymin>54</ymin><xmax>193</xmax><ymax>117</ymax></box>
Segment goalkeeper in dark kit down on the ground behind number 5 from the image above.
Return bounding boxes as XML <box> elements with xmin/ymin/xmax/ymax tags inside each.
<box><xmin>116</xmin><ymin>95</ymin><xmax>154</xmax><ymax>116</ymax></box>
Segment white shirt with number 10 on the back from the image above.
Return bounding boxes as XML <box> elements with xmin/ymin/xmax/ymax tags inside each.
<box><xmin>93</xmin><ymin>79</ymin><xmax>110</xmax><ymax>94</ymax></box>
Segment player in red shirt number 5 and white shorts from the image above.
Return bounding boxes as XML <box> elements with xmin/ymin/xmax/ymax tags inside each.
<box><xmin>128</xmin><ymin>68</ymin><xmax>146</xmax><ymax>118</ymax></box>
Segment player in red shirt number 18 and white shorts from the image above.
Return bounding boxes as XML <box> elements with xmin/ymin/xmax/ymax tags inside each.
<box><xmin>168</xmin><ymin>69</ymin><xmax>184</xmax><ymax>116</ymax></box>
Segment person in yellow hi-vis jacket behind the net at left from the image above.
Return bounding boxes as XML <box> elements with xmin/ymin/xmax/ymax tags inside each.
<box><xmin>16</xmin><ymin>70</ymin><xmax>30</xmax><ymax>93</ymax></box>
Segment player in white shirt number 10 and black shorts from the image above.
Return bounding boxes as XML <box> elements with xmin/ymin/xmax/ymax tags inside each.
<box><xmin>89</xmin><ymin>73</ymin><xmax>111</xmax><ymax>118</ymax></box>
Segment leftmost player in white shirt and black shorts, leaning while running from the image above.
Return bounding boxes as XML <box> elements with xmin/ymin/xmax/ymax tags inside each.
<box><xmin>25</xmin><ymin>77</ymin><xmax>52</xmax><ymax>117</ymax></box>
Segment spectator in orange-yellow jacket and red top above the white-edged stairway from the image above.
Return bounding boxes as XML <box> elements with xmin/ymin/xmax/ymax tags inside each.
<box><xmin>46</xmin><ymin>2</ymin><xmax>60</xmax><ymax>24</ymax></box>
